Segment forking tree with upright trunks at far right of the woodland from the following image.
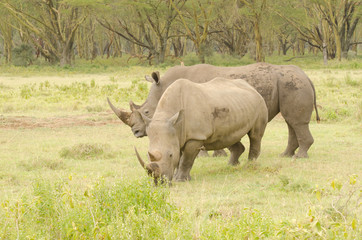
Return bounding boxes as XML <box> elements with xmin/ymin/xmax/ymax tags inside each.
<box><xmin>274</xmin><ymin>0</ymin><xmax>361</xmax><ymax>60</ymax></box>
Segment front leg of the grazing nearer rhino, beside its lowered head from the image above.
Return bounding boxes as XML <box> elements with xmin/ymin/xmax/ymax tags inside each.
<box><xmin>175</xmin><ymin>140</ymin><xmax>203</xmax><ymax>182</ymax></box>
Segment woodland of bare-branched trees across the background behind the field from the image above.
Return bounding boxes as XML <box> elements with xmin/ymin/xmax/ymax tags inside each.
<box><xmin>0</xmin><ymin>0</ymin><xmax>362</xmax><ymax>66</ymax></box>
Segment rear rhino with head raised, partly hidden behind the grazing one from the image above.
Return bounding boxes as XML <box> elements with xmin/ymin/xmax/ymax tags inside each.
<box><xmin>110</xmin><ymin>63</ymin><xmax>319</xmax><ymax>158</ymax></box>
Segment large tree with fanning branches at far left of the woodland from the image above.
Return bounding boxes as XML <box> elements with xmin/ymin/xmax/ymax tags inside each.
<box><xmin>0</xmin><ymin>0</ymin><xmax>88</xmax><ymax>66</ymax></box>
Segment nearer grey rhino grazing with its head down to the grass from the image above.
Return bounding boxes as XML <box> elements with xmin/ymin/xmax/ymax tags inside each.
<box><xmin>136</xmin><ymin>77</ymin><xmax>268</xmax><ymax>183</ymax></box>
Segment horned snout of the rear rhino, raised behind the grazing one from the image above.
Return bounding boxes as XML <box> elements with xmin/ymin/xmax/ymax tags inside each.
<box><xmin>107</xmin><ymin>98</ymin><xmax>147</xmax><ymax>138</ymax></box>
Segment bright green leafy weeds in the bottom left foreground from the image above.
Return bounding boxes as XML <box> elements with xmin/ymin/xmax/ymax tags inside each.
<box><xmin>0</xmin><ymin>177</ymin><xmax>180</xmax><ymax>239</ymax></box>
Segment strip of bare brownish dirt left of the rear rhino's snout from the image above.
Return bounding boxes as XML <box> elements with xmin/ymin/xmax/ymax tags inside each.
<box><xmin>0</xmin><ymin>112</ymin><xmax>121</xmax><ymax>129</ymax></box>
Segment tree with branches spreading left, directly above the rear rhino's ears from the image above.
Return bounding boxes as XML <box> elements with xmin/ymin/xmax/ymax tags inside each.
<box><xmin>98</xmin><ymin>0</ymin><xmax>185</xmax><ymax>63</ymax></box>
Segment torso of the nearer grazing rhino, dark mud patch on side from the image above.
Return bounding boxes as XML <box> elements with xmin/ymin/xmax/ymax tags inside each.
<box><xmin>153</xmin><ymin>78</ymin><xmax>267</xmax><ymax>147</ymax></box>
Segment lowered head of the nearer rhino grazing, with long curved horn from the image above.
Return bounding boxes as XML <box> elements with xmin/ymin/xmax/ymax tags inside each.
<box><xmin>135</xmin><ymin>110</ymin><xmax>184</xmax><ymax>185</ymax></box>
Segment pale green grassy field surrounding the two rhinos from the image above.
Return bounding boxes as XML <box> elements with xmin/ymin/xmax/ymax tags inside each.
<box><xmin>0</xmin><ymin>60</ymin><xmax>362</xmax><ymax>239</ymax></box>
